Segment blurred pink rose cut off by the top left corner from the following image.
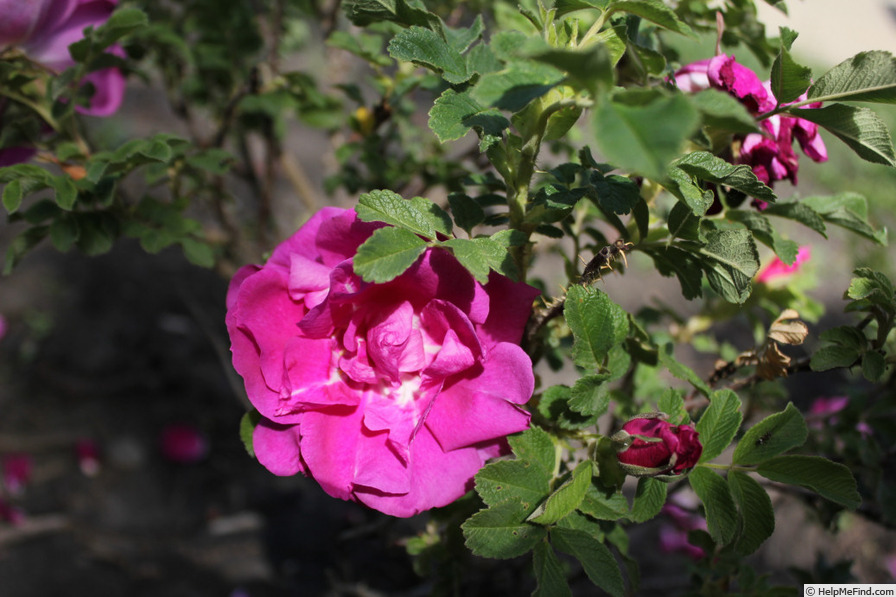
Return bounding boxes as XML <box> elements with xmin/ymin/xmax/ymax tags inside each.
<box><xmin>0</xmin><ymin>0</ymin><xmax>125</xmax><ymax>116</ymax></box>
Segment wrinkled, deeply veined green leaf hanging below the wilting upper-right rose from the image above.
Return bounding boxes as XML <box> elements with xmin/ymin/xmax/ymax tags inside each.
<box><xmin>699</xmin><ymin>229</ymin><xmax>759</xmax><ymax>304</ymax></box>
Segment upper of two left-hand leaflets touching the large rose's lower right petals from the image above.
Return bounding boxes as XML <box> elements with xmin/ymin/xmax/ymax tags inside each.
<box><xmin>476</xmin><ymin>460</ymin><xmax>552</xmax><ymax>512</ymax></box>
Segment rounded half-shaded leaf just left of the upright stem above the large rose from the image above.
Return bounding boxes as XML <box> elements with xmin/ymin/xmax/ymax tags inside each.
<box><xmin>429</xmin><ymin>88</ymin><xmax>510</xmax><ymax>143</ymax></box>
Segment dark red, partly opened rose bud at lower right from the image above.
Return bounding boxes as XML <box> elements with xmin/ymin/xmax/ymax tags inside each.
<box><xmin>612</xmin><ymin>415</ymin><xmax>703</xmax><ymax>477</ymax></box>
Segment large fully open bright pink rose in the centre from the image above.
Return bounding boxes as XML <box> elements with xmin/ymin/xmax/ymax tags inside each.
<box><xmin>227</xmin><ymin>208</ymin><xmax>537</xmax><ymax>516</ymax></box>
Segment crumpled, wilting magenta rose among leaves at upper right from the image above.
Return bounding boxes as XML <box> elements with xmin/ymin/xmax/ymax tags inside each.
<box><xmin>675</xmin><ymin>54</ymin><xmax>828</xmax><ymax>207</ymax></box>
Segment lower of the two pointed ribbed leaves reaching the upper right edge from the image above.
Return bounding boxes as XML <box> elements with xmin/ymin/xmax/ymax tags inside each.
<box><xmin>788</xmin><ymin>104</ymin><xmax>896</xmax><ymax>167</ymax></box>
